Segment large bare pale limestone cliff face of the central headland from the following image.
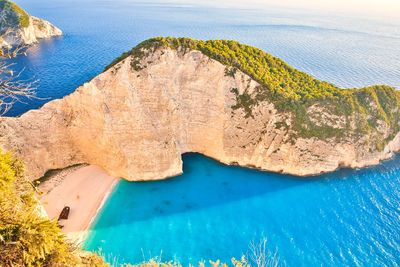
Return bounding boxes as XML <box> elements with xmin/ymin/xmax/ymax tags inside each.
<box><xmin>0</xmin><ymin>38</ymin><xmax>400</xmax><ymax>181</ymax></box>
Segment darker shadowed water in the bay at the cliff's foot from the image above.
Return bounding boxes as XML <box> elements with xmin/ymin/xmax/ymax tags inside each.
<box><xmin>88</xmin><ymin>153</ymin><xmax>334</xmax><ymax>229</ymax></box>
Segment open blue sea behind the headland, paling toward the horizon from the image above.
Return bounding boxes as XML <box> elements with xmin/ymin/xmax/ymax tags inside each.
<box><xmin>8</xmin><ymin>0</ymin><xmax>400</xmax><ymax>116</ymax></box>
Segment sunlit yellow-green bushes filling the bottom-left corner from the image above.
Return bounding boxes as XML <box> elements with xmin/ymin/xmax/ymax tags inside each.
<box><xmin>0</xmin><ymin>151</ymin><xmax>107</xmax><ymax>266</ymax></box>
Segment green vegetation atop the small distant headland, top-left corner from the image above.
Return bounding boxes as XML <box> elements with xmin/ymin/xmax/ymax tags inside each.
<box><xmin>0</xmin><ymin>0</ymin><xmax>29</xmax><ymax>29</ymax></box>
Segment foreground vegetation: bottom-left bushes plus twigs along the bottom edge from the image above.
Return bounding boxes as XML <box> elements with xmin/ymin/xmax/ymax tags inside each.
<box><xmin>0</xmin><ymin>151</ymin><xmax>280</xmax><ymax>267</ymax></box>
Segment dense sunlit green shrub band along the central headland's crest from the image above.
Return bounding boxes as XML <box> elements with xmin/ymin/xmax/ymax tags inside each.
<box><xmin>107</xmin><ymin>37</ymin><xmax>340</xmax><ymax>100</ymax></box>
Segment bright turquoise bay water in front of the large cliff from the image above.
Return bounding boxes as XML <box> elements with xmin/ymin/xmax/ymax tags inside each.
<box><xmin>85</xmin><ymin>154</ymin><xmax>400</xmax><ymax>266</ymax></box>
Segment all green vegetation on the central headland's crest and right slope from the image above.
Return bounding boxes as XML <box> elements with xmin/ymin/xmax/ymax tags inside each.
<box><xmin>106</xmin><ymin>37</ymin><xmax>400</xmax><ymax>149</ymax></box>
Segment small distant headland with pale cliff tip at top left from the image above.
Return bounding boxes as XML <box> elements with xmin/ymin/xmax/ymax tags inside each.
<box><xmin>0</xmin><ymin>0</ymin><xmax>62</xmax><ymax>48</ymax></box>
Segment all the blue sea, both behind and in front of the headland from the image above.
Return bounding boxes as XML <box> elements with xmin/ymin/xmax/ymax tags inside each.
<box><xmin>8</xmin><ymin>0</ymin><xmax>400</xmax><ymax>266</ymax></box>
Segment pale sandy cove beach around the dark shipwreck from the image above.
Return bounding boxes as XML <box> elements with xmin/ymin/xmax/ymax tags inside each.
<box><xmin>39</xmin><ymin>165</ymin><xmax>118</xmax><ymax>243</ymax></box>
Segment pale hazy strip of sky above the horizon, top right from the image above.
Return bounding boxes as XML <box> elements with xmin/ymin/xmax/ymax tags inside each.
<box><xmin>195</xmin><ymin>0</ymin><xmax>400</xmax><ymax>19</ymax></box>
